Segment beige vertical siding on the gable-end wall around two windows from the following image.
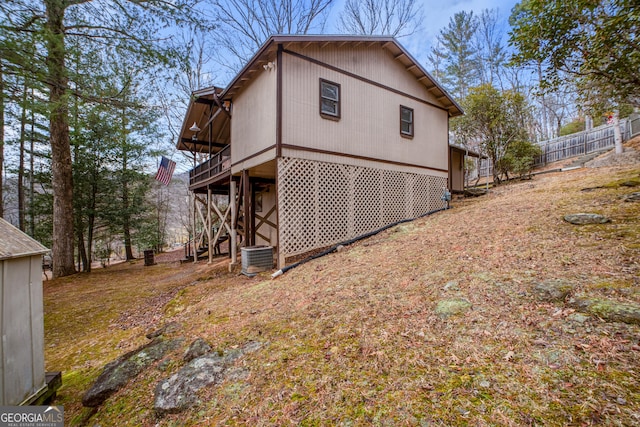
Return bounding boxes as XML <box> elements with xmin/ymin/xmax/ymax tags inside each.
<box><xmin>282</xmin><ymin>48</ymin><xmax>448</xmax><ymax>169</ymax></box>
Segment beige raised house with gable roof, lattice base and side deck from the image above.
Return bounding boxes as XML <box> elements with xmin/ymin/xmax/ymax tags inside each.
<box><xmin>178</xmin><ymin>35</ymin><xmax>462</xmax><ymax>267</ymax></box>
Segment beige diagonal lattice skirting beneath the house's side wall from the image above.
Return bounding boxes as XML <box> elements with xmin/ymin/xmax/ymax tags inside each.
<box><xmin>278</xmin><ymin>157</ymin><xmax>447</xmax><ymax>256</ymax></box>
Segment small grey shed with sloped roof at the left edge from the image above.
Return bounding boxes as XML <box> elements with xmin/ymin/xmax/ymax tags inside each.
<box><xmin>0</xmin><ymin>218</ymin><xmax>58</xmax><ymax>406</ymax></box>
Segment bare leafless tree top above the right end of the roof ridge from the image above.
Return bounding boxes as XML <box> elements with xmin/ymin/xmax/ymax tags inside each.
<box><xmin>338</xmin><ymin>0</ymin><xmax>422</xmax><ymax>37</ymax></box>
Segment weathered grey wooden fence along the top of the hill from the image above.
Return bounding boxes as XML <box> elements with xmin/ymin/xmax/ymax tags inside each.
<box><xmin>478</xmin><ymin>115</ymin><xmax>640</xmax><ymax>176</ymax></box>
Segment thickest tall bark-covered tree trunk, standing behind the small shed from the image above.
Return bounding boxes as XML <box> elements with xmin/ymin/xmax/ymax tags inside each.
<box><xmin>45</xmin><ymin>0</ymin><xmax>76</xmax><ymax>277</ymax></box>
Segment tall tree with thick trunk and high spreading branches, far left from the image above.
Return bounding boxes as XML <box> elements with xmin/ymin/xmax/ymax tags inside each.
<box><xmin>0</xmin><ymin>0</ymin><xmax>202</xmax><ymax>277</ymax></box>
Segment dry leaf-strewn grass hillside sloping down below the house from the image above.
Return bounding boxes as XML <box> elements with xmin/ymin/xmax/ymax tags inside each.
<box><xmin>45</xmin><ymin>161</ymin><xmax>640</xmax><ymax>427</ymax></box>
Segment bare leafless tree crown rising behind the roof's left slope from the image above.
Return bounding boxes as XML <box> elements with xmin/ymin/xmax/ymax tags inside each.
<box><xmin>212</xmin><ymin>0</ymin><xmax>333</xmax><ymax>73</ymax></box>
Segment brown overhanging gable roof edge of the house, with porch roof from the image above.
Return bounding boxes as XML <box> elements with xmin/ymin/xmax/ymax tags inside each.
<box><xmin>178</xmin><ymin>35</ymin><xmax>464</xmax><ymax>152</ymax></box>
